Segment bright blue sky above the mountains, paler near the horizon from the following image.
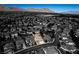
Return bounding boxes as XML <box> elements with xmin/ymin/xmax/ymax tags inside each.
<box><xmin>1</xmin><ymin>4</ymin><xmax>79</xmax><ymax>12</ymax></box>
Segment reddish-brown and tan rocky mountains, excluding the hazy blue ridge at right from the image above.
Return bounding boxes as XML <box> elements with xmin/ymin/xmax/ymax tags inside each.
<box><xmin>0</xmin><ymin>6</ymin><xmax>54</xmax><ymax>12</ymax></box>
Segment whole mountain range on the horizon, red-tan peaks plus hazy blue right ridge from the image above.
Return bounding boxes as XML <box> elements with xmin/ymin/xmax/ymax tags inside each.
<box><xmin>0</xmin><ymin>6</ymin><xmax>79</xmax><ymax>14</ymax></box>
